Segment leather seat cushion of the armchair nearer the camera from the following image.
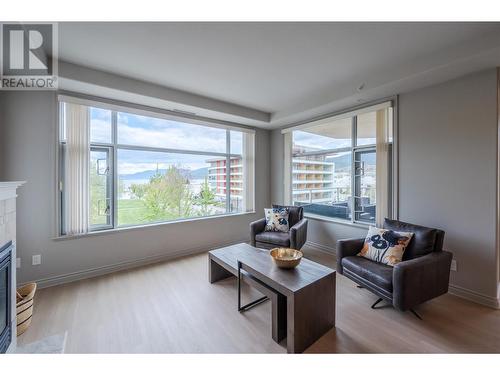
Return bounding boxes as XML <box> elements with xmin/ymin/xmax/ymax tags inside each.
<box><xmin>342</xmin><ymin>256</ymin><xmax>394</xmax><ymax>293</ymax></box>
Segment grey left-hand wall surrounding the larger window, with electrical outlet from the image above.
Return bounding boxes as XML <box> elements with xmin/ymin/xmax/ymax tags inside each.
<box><xmin>0</xmin><ymin>92</ymin><xmax>270</xmax><ymax>283</ymax></box>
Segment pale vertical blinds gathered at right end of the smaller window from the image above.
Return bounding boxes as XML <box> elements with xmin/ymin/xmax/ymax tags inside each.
<box><xmin>375</xmin><ymin>108</ymin><xmax>390</xmax><ymax>226</ymax></box>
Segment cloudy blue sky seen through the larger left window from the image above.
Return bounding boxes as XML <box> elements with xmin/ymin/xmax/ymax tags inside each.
<box><xmin>90</xmin><ymin>108</ymin><xmax>243</xmax><ymax>174</ymax></box>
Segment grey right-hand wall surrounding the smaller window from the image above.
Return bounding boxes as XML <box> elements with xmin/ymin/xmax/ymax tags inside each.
<box><xmin>271</xmin><ymin>69</ymin><xmax>498</xmax><ymax>303</ymax></box>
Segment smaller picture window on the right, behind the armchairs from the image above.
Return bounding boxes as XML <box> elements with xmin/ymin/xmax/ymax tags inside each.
<box><xmin>283</xmin><ymin>102</ymin><xmax>394</xmax><ymax>223</ymax></box>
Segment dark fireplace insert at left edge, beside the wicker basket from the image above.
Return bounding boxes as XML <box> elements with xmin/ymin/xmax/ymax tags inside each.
<box><xmin>0</xmin><ymin>241</ymin><xmax>12</xmax><ymax>353</ymax></box>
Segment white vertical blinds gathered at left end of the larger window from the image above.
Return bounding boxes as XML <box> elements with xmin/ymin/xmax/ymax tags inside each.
<box><xmin>64</xmin><ymin>103</ymin><xmax>90</xmax><ymax>235</ymax></box>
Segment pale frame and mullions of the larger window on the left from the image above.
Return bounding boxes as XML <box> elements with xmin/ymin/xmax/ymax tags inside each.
<box><xmin>56</xmin><ymin>95</ymin><xmax>255</xmax><ymax>237</ymax></box>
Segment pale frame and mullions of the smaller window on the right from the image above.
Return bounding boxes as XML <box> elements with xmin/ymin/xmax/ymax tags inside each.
<box><xmin>282</xmin><ymin>96</ymin><xmax>399</xmax><ymax>227</ymax></box>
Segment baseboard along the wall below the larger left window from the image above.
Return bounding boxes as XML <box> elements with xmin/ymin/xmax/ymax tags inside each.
<box><xmin>23</xmin><ymin>238</ymin><xmax>248</xmax><ymax>289</ymax></box>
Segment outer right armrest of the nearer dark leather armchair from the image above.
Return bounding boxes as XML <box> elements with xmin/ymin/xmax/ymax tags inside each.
<box><xmin>392</xmin><ymin>251</ymin><xmax>453</xmax><ymax>311</ymax></box>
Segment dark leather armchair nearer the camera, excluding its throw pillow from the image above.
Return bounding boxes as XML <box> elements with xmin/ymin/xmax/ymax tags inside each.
<box><xmin>337</xmin><ymin>219</ymin><xmax>452</xmax><ymax>318</ymax></box>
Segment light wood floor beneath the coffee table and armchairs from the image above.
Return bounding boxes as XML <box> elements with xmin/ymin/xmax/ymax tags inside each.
<box><xmin>18</xmin><ymin>249</ymin><xmax>500</xmax><ymax>353</ymax></box>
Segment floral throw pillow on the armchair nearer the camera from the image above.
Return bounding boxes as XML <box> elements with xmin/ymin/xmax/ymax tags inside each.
<box><xmin>358</xmin><ymin>226</ymin><xmax>413</xmax><ymax>266</ymax></box>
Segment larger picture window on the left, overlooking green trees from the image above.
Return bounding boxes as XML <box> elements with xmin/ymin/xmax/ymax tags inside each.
<box><xmin>59</xmin><ymin>99</ymin><xmax>254</xmax><ymax>235</ymax></box>
